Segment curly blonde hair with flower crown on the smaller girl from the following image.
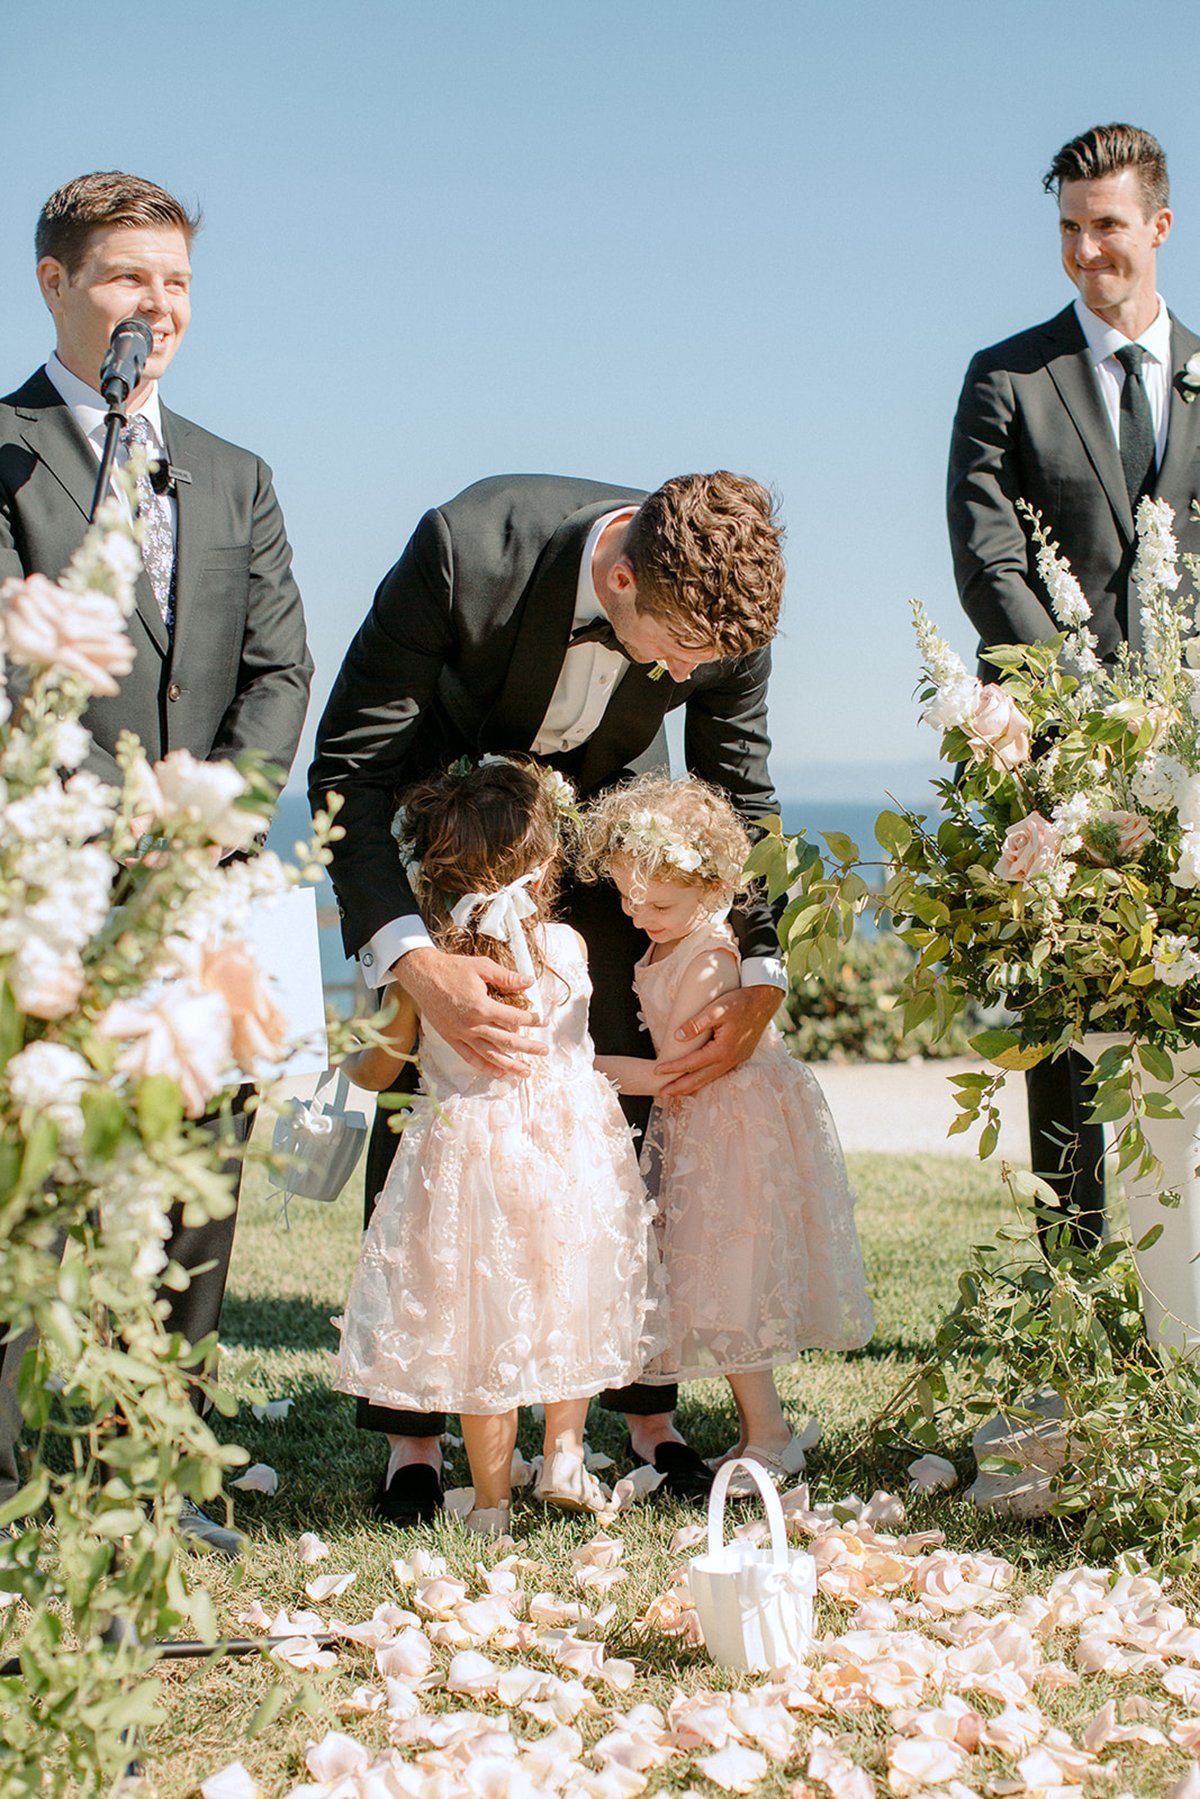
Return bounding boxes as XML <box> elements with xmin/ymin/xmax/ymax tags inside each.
<box><xmin>574</xmin><ymin>774</ymin><xmax>750</xmax><ymax>907</ymax></box>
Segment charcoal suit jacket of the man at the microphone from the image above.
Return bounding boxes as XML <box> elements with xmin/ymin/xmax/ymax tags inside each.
<box><xmin>0</xmin><ymin>371</ymin><xmax>313</xmax><ymax>781</ymax></box>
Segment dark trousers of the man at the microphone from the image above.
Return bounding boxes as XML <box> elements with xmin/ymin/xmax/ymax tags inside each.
<box><xmin>0</xmin><ymin>1087</ymin><xmax>252</xmax><ymax>1504</ymax></box>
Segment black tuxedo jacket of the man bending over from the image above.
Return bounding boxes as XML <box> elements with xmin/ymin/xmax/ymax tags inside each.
<box><xmin>309</xmin><ymin>475</ymin><xmax>779</xmax><ymax>955</ymax></box>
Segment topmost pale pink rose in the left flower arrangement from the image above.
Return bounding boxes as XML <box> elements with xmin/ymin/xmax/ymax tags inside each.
<box><xmin>0</xmin><ymin>574</ymin><xmax>135</xmax><ymax>700</ymax></box>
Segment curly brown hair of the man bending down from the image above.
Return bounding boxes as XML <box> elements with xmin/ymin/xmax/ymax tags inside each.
<box><xmin>624</xmin><ymin>468</ymin><xmax>784</xmax><ymax>657</ymax></box>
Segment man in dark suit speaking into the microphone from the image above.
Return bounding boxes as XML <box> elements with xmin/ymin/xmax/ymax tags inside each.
<box><xmin>0</xmin><ymin>173</ymin><xmax>313</xmax><ymax>1554</ymax></box>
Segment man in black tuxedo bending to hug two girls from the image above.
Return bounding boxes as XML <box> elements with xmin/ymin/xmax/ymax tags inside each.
<box><xmin>309</xmin><ymin>471</ymin><xmax>783</xmax><ymax>1522</ymax></box>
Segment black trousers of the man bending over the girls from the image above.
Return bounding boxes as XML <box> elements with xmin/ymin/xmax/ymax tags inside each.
<box><xmin>356</xmin><ymin>883</ymin><xmax>678</xmax><ymax>1437</ymax></box>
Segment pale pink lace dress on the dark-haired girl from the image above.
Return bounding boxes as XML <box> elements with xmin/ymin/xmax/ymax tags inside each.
<box><xmin>333</xmin><ymin>925</ymin><xmax>664</xmax><ymax>1412</ymax></box>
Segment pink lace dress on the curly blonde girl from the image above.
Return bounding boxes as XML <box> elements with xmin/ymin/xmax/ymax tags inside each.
<box><xmin>635</xmin><ymin>921</ymin><xmax>874</xmax><ymax>1382</ymax></box>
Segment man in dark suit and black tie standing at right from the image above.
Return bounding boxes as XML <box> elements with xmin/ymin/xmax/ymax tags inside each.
<box><xmin>948</xmin><ymin>124</ymin><xmax>1200</xmax><ymax>1243</ymax></box>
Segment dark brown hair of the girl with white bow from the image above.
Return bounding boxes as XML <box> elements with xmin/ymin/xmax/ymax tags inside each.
<box><xmin>398</xmin><ymin>761</ymin><xmax>558</xmax><ymax>1006</ymax></box>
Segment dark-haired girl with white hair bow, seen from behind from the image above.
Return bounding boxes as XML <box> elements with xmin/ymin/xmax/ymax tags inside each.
<box><xmin>335</xmin><ymin>761</ymin><xmax>662</xmax><ymax>1536</ymax></box>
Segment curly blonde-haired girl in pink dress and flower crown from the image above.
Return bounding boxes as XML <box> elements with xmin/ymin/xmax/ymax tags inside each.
<box><xmin>578</xmin><ymin>775</ymin><xmax>874</xmax><ymax>1475</ymax></box>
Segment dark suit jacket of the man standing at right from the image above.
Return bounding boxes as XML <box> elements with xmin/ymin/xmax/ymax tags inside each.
<box><xmin>948</xmin><ymin>306</ymin><xmax>1200</xmax><ymax>657</ymax></box>
